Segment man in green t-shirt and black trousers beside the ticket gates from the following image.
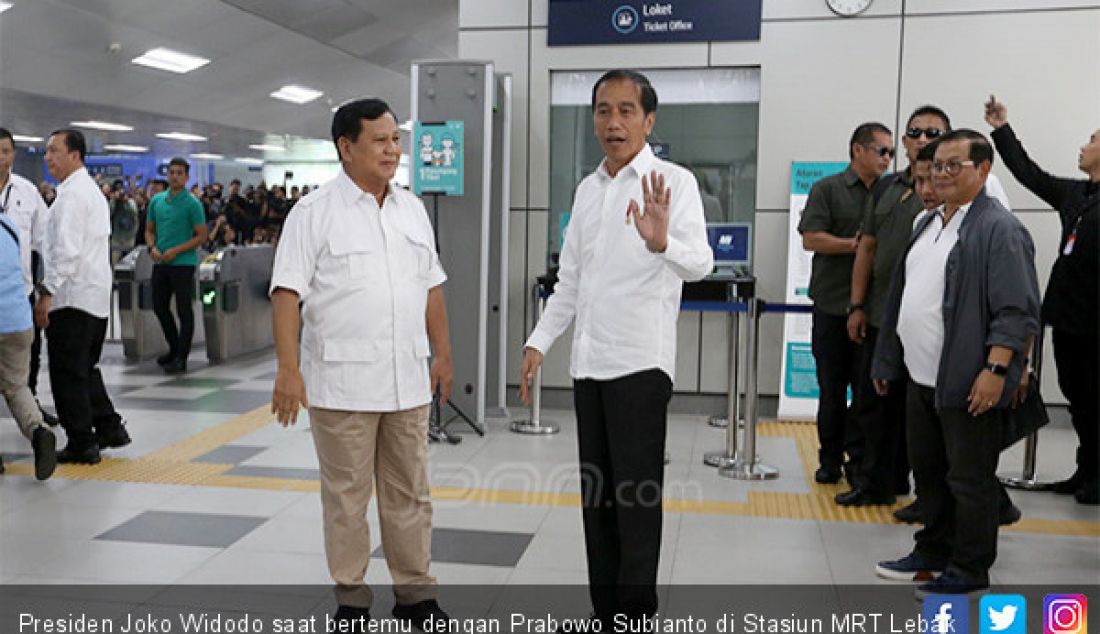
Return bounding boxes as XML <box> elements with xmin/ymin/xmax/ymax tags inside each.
<box><xmin>145</xmin><ymin>157</ymin><xmax>207</xmax><ymax>374</ymax></box>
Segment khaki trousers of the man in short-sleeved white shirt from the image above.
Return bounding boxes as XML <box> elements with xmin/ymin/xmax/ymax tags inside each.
<box><xmin>309</xmin><ymin>405</ymin><xmax>436</xmax><ymax>608</ymax></box>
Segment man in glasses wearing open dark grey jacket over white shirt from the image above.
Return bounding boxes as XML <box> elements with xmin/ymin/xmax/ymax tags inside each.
<box><xmin>871</xmin><ymin>130</ymin><xmax>1040</xmax><ymax>597</ymax></box>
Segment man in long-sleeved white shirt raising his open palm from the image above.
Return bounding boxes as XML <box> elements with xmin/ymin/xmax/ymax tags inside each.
<box><xmin>519</xmin><ymin>69</ymin><xmax>714</xmax><ymax>628</ymax></box>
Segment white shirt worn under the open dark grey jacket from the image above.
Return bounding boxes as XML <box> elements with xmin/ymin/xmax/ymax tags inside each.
<box><xmin>898</xmin><ymin>203</ymin><xmax>972</xmax><ymax>387</ymax></box>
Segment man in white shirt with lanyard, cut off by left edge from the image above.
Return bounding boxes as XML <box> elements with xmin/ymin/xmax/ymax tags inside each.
<box><xmin>0</xmin><ymin>128</ymin><xmax>57</xmax><ymax>426</ymax></box>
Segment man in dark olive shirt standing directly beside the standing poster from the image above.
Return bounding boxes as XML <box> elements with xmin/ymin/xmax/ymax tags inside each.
<box><xmin>799</xmin><ymin>123</ymin><xmax>894</xmax><ymax>483</ymax></box>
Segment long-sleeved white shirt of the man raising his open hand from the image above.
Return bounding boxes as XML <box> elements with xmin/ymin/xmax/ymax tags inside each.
<box><xmin>527</xmin><ymin>143</ymin><xmax>714</xmax><ymax>380</ymax></box>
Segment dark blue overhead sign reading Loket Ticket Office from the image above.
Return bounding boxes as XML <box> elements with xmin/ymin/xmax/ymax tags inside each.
<box><xmin>547</xmin><ymin>0</ymin><xmax>761</xmax><ymax>46</ymax></box>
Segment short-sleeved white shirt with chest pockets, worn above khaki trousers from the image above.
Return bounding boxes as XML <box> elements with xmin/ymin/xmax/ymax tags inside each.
<box><xmin>271</xmin><ymin>170</ymin><xmax>447</xmax><ymax>412</ymax></box>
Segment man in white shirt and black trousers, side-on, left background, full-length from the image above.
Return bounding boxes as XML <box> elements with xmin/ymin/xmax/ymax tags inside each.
<box><xmin>34</xmin><ymin>130</ymin><xmax>130</xmax><ymax>464</ymax></box>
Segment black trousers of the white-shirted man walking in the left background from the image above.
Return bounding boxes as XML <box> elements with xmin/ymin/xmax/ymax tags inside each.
<box><xmin>46</xmin><ymin>308</ymin><xmax>122</xmax><ymax>449</ymax></box>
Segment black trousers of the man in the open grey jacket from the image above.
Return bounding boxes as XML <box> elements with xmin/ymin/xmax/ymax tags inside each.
<box><xmin>906</xmin><ymin>382</ymin><xmax>1003</xmax><ymax>583</ymax></box>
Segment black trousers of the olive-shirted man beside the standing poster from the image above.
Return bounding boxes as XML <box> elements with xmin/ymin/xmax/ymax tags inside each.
<box><xmin>812</xmin><ymin>307</ymin><xmax>864</xmax><ymax>471</ymax></box>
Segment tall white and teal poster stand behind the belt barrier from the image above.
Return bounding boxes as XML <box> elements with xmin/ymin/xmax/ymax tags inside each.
<box><xmin>779</xmin><ymin>161</ymin><xmax>848</xmax><ymax>420</ymax></box>
